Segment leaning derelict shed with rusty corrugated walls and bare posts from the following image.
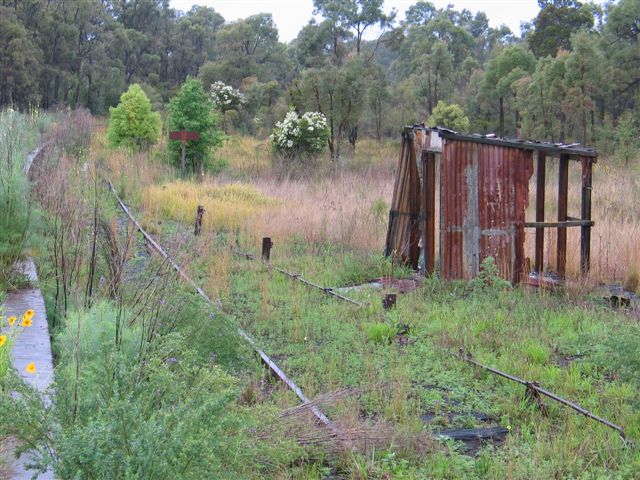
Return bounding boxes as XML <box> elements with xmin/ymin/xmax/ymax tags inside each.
<box><xmin>385</xmin><ymin>125</ymin><xmax>597</xmax><ymax>283</ymax></box>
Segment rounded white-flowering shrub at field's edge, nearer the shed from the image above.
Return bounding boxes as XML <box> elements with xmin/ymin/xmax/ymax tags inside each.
<box><xmin>271</xmin><ymin>110</ymin><xmax>329</xmax><ymax>155</ymax></box>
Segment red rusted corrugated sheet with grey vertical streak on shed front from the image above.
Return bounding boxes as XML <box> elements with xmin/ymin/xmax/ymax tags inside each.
<box><xmin>440</xmin><ymin>139</ymin><xmax>533</xmax><ymax>281</ymax></box>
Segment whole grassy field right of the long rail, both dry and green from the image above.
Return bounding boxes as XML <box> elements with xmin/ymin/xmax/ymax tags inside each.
<box><xmin>32</xmin><ymin>121</ymin><xmax>640</xmax><ymax>479</ymax></box>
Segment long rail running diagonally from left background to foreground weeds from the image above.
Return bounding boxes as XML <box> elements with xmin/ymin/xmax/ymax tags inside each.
<box><xmin>109</xmin><ymin>181</ymin><xmax>333</xmax><ymax>427</ymax></box>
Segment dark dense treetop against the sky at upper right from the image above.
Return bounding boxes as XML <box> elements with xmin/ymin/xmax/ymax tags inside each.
<box><xmin>528</xmin><ymin>0</ymin><xmax>593</xmax><ymax>57</ymax></box>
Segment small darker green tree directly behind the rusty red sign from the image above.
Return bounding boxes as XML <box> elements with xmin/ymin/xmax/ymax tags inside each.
<box><xmin>169</xmin><ymin>77</ymin><xmax>224</xmax><ymax>173</ymax></box>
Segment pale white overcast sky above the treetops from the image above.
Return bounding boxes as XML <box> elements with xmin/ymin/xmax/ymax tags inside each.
<box><xmin>170</xmin><ymin>0</ymin><xmax>538</xmax><ymax>42</ymax></box>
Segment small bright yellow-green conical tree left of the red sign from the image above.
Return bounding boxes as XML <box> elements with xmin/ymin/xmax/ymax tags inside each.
<box><xmin>107</xmin><ymin>83</ymin><xmax>162</xmax><ymax>149</ymax></box>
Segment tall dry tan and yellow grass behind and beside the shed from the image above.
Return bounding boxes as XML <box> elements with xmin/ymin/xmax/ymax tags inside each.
<box><xmin>109</xmin><ymin>131</ymin><xmax>640</xmax><ymax>282</ymax></box>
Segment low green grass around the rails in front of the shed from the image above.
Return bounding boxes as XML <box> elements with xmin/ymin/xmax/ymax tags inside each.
<box><xmin>129</xmin><ymin>194</ymin><xmax>640</xmax><ymax>479</ymax></box>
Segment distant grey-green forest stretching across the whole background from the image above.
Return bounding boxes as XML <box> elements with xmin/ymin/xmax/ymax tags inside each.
<box><xmin>0</xmin><ymin>0</ymin><xmax>640</xmax><ymax>153</ymax></box>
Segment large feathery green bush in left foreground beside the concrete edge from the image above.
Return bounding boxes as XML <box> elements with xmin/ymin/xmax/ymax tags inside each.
<box><xmin>0</xmin><ymin>303</ymin><xmax>296</xmax><ymax>479</ymax></box>
